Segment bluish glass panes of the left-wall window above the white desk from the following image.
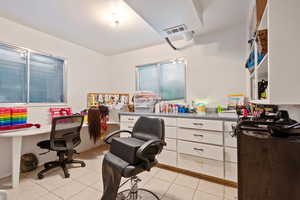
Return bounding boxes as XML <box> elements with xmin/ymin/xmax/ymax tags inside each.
<box><xmin>0</xmin><ymin>44</ymin><xmax>65</xmax><ymax>103</ymax></box>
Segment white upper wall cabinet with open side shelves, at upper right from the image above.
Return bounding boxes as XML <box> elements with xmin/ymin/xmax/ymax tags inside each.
<box><xmin>248</xmin><ymin>0</ymin><xmax>300</xmax><ymax>105</ymax></box>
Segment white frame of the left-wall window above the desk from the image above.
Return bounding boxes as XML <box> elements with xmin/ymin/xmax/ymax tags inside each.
<box><xmin>0</xmin><ymin>41</ymin><xmax>68</xmax><ymax>107</ymax></box>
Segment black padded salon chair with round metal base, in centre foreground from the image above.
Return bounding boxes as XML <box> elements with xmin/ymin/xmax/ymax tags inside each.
<box><xmin>102</xmin><ymin>117</ymin><xmax>166</xmax><ymax>200</ymax></box>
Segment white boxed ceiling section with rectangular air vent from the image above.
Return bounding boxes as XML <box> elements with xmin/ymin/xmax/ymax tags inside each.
<box><xmin>125</xmin><ymin>0</ymin><xmax>203</xmax><ymax>38</ymax></box>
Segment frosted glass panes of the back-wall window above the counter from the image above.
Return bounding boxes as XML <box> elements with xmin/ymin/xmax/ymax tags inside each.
<box><xmin>137</xmin><ymin>59</ymin><xmax>186</xmax><ymax>100</ymax></box>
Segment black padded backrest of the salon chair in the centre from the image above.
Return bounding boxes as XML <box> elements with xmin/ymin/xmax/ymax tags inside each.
<box><xmin>132</xmin><ymin>117</ymin><xmax>165</xmax><ymax>141</ymax></box>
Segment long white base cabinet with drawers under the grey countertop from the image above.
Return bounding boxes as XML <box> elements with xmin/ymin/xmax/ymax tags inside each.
<box><xmin>121</xmin><ymin>114</ymin><xmax>237</xmax><ymax>181</ymax></box>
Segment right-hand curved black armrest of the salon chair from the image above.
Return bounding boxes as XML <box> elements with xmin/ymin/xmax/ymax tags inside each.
<box><xmin>136</xmin><ymin>139</ymin><xmax>167</xmax><ymax>171</ymax></box>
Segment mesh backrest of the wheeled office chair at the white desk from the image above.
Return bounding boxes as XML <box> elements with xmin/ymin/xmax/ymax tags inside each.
<box><xmin>50</xmin><ymin>115</ymin><xmax>83</xmax><ymax>151</ymax></box>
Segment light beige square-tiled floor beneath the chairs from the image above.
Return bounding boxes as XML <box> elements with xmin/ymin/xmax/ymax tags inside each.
<box><xmin>0</xmin><ymin>148</ymin><xmax>237</xmax><ymax>200</ymax></box>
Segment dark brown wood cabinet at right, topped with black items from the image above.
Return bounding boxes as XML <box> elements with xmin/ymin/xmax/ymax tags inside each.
<box><xmin>238</xmin><ymin>131</ymin><xmax>300</xmax><ymax>200</ymax></box>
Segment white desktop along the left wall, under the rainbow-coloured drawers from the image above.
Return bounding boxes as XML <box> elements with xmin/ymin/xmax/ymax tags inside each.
<box><xmin>0</xmin><ymin>122</ymin><xmax>119</xmax><ymax>138</ymax></box>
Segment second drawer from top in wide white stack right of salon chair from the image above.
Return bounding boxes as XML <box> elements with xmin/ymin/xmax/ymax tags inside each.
<box><xmin>177</xmin><ymin>128</ymin><xmax>223</xmax><ymax>145</ymax></box>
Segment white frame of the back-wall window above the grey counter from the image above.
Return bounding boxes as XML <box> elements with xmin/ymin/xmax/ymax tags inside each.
<box><xmin>135</xmin><ymin>57</ymin><xmax>188</xmax><ymax>103</ymax></box>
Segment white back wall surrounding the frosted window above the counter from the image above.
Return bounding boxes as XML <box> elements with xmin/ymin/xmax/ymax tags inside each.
<box><xmin>111</xmin><ymin>25</ymin><xmax>247</xmax><ymax>106</ymax></box>
